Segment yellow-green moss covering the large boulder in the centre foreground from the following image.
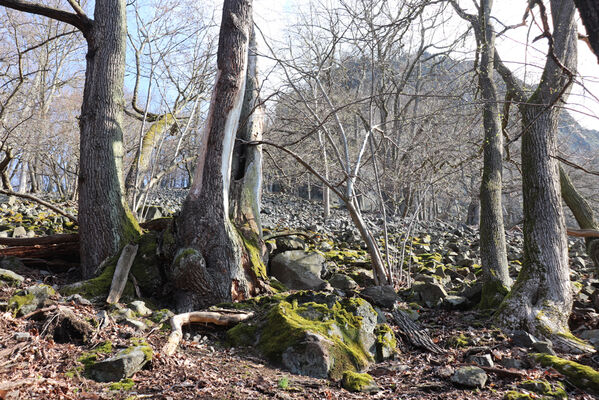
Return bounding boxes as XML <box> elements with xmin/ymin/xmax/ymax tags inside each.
<box><xmin>258</xmin><ymin>299</ymin><xmax>372</xmax><ymax>379</ymax></box>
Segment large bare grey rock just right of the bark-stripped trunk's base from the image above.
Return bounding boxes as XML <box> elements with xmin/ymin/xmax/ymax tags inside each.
<box><xmin>270</xmin><ymin>250</ymin><xmax>326</xmax><ymax>290</ymax></box>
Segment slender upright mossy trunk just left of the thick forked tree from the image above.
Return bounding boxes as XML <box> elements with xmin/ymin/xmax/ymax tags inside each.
<box><xmin>453</xmin><ymin>0</ymin><xmax>512</xmax><ymax>308</ymax></box>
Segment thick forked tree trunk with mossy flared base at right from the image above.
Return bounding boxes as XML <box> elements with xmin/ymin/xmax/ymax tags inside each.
<box><xmin>495</xmin><ymin>0</ymin><xmax>591</xmax><ymax>351</ymax></box>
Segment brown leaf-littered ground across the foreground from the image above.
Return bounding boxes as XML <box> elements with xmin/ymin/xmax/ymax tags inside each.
<box><xmin>0</xmin><ymin>264</ymin><xmax>597</xmax><ymax>400</ymax></box>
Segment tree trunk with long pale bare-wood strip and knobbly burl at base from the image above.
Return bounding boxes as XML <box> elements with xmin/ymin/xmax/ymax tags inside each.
<box><xmin>168</xmin><ymin>0</ymin><xmax>265</xmax><ymax>311</ymax></box>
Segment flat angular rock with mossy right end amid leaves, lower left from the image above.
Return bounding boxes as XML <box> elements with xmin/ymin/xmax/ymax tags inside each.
<box><xmin>86</xmin><ymin>343</ymin><xmax>152</xmax><ymax>382</ymax></box>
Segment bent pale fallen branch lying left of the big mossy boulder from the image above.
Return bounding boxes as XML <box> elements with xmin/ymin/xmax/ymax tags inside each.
<box><xmin>162</xmin><ymin>310</ymin><xmax>254</xmax><ymax>356</ymax></box>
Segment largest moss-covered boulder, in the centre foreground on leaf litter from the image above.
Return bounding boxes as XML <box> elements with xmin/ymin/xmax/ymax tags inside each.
<box><xmin>228</xmin><ymin>292</ymin><xmax>395</xmax><ymax>379</ymax></box>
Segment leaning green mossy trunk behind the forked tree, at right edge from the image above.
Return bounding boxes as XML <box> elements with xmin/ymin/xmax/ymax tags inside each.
<box><xmin>559</xmin><ymin>166</ymin><xmax>599</xmax><ymax>269</ymax></box>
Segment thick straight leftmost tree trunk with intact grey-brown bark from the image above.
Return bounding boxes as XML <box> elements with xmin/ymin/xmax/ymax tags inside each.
<box><xmin>79</xmin><ymin>0</ymin><xmax>139</xmax><ymax>278</ymax></box>
